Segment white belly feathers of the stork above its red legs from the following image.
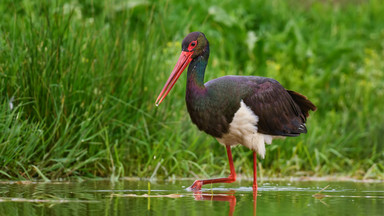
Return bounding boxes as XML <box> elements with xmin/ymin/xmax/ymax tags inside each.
<box><xmin>217</xmin><ymin>101</ymin><xmax>274</xmax><ymax>158</ymax></box>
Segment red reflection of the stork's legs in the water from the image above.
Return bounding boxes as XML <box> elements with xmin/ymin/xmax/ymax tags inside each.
<box><xmin>193</xmin><ymin>190</ymin><xmax>257</xmax><ymax>216</ymax></box>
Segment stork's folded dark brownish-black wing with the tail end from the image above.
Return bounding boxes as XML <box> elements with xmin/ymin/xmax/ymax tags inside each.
<box><xmin>243</xmin><ymin>77</ymin><xmax>316</xmax><ymax>136</ymax></box>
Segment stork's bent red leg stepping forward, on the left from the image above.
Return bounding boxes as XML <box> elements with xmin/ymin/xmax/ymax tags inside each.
<box><xmin>189</xmin><ymin>146</ymin><xmax>236</xmax><ymax>191</ymax></box>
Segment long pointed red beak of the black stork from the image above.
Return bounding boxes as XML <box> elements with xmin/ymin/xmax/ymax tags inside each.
<box><xmin>156</xmin><ymin>51</ymin><xmax>193</xmax><ymax>106</ymax></box>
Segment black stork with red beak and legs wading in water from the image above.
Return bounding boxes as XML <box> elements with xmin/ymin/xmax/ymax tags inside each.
<box><xmin>156</xmin><ymin>32</ymin><xmax>316</xmax><ymax>191</ymax></box>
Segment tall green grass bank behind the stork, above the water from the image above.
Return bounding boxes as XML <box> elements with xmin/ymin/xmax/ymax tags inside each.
<box><xmin>0</xmin><ymin>0</ymin><xmax>384</xmax><ymax>180</ymax></box>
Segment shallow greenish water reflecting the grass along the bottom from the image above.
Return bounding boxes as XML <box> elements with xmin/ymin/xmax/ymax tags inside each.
<box><xmin>0</xmin><ymin>180</ymin><xmax>384</xmax><ymax>216</ymax></box>
